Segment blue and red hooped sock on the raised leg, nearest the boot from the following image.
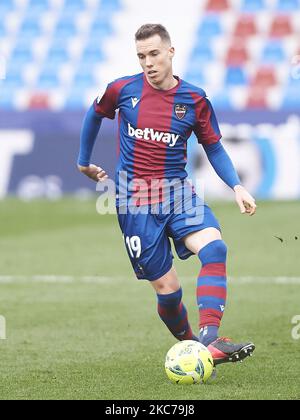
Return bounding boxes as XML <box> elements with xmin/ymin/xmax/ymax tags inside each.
<box><xmin>197</xmin><ymin>240</ymin><xmax>227</xmax><ymax>346</ymax></box>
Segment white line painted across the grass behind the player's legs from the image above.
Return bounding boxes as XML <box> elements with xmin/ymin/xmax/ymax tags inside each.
<box><xmin>0</xmin><ymin>275</ymin><xmax>300</xmax><ymax>285</ymax></box>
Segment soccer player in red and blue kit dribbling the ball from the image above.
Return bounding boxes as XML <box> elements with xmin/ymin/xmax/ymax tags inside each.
<box><xmin>78</xmin><ymin>24</ymin><xmax>256</xmax><ymax>365</ymax></box>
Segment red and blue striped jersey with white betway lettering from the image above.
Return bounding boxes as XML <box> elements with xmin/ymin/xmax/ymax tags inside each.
<box><xmin>94</xmin><ymin>73</ymin><xmax>221</xmax><ymax>205</ymax></box>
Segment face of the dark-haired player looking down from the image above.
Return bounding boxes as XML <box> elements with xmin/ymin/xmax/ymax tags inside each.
<box><xmin>136</xmin><ymin>35</ymin><xmax>174</xmax><ymax>87</ymax></box>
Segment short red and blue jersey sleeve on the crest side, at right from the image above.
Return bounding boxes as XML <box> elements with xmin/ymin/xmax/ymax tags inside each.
<box><xmin>194</xmin><ymin>97</ymin><xmax>222</xmax><ymax>146</ymax></box>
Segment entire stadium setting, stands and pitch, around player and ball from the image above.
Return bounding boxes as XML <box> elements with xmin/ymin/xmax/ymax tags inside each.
<box><xmin>0</xmin><ymin>0</ymin><xmax>300</xmax><ymax>400</ymax></box>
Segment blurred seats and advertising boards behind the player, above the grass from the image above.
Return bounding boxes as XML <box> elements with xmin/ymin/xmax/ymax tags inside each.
<box><xmin>0</xmin><ymin>0</ymin><xmax>300</xmax><ymax>199</ymax></box>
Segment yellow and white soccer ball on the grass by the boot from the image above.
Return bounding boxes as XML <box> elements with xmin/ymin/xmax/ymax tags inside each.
<box><xmin>165</xmin><ymin>340</ymin><xmax>214</xmax><ymax>385</ymax></box>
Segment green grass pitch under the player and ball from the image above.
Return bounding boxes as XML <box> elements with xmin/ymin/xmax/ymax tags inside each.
<box><xmin>0</xmin><ymin>199</ymin><xmax>300</xmax><ymax>400</ymax></box>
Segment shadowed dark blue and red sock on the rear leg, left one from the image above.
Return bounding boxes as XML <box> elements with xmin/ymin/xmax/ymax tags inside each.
<box><xmin>157</xmin><ymin>288</ymin><xmax>199</xmax><ymax>341</ymax></box>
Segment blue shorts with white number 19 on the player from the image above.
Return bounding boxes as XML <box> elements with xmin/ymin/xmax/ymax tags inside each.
<box><xmin>117</xmin><ymin>194</ymin><xmax>221</xmax><ymax>281</ymax></box>
